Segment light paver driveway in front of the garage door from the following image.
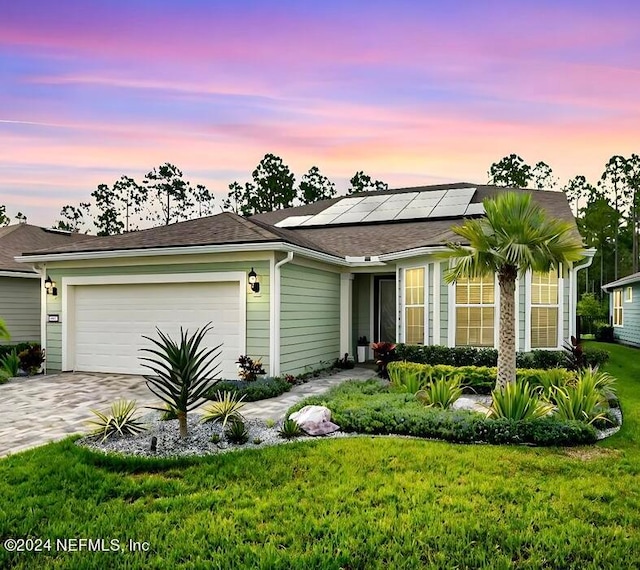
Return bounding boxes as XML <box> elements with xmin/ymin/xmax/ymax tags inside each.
<box><xmin>0</xmin><ymin>372</ymin><xmax>161</xmax><ymax>456</ymax></box>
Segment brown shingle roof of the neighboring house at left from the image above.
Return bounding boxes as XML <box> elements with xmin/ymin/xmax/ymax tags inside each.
<box><xmin>0</xmin><ymin>224</ymin><xmax>95</xmax><ymax>273</ymax></box>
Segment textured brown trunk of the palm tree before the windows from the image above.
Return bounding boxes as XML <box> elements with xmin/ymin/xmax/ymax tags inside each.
<box><xmin>496</xmin><ymin>265</ymin><xmax>518</xmax><ymax>390</ymax></box>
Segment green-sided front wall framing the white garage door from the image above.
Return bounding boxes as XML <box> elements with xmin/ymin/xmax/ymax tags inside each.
<box><xmin>47</xmin><ymin>260</ymin><xmax>271</xmax><ymax>372</ymax></box>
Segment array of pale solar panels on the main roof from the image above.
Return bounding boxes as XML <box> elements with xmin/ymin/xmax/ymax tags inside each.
<box><xmin>276</xmin><ymin>188</ymin><xmax>484</xmax><ymax>228</ymax></box>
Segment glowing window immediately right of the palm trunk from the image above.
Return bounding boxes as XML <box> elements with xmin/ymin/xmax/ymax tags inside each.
<box><xmin>531</xmin><ymin>270</ymin><xmax>559</xmax><ymax>348</ymax></box>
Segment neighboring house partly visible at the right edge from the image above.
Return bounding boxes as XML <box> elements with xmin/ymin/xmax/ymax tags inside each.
<box><xmin>602</xmin><ymin>273</ymin><xmax>640</xmax><ymax>346</ymax></box>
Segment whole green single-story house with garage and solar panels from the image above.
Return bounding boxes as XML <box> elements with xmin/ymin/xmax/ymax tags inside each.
<box><xmin>20</xmin><ymin>183</ymin><xmax>592</xmax><ymax>377</ymax></box>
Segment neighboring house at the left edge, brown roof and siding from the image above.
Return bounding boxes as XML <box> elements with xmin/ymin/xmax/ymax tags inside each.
<box><xmin>0</xmin><ymin>224</ymin><xmax>91</xmax><ymax>344</ymax></box>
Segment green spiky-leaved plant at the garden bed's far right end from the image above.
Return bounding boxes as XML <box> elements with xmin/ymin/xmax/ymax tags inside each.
<box><xmin>552</xmin><ymin>368</ymin><xmax>615</xmax><ymax>424</ymax></box>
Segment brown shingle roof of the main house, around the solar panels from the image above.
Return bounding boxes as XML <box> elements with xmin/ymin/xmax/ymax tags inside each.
<box><xmin>18</xmin><ymin>183</ymin><xmax>577</xmax><ymax>257</ymax></box>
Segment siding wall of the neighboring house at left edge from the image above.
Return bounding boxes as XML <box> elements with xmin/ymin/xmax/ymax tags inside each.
<box><xmin>0</xmin><ymin>277</ymin><xmax>40</xmax><ymax>344</ymax></box>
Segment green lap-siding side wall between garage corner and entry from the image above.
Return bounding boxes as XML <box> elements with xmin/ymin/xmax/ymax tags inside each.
<box><xmin>280</xmin><ymin>263</ymin><xmax>340</xmax><ymax>374</ymax></box>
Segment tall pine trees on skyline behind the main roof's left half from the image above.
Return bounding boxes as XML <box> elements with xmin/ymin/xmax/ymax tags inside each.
<box><xmin>43</xmin><ymin>154</ymin><xmax>388</xmax><ymax>236</ymax></box>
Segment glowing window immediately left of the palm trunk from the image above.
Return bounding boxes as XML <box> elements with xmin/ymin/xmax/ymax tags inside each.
<box><xmin>456</xmin><ymin>275</ymin><xmax>495</xmax><ymax>346</ymax></box>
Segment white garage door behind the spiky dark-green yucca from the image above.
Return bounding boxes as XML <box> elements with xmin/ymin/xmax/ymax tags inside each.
<box><xmin>70</xmin><ymin>282</ymin><xmax>244</xmax><ymax>378</ymax></box>
